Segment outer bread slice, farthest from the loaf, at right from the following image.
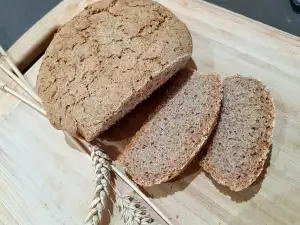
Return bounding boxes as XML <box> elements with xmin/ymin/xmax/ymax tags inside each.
<box><xmin>200</xmin><ymin>75</ymin><xmax>274</xmax><ymax>191</ymax></box>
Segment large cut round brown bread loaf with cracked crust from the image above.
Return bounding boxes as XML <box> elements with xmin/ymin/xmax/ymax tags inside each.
<box><xmin>37</xmin><ymin>0</ymin><xmax>192</xmax><ymax>141</ymax></box>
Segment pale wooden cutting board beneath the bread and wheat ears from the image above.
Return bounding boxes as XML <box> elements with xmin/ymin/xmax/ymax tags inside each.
<box><xmin>0</xmin><ymin>0</ymin><xmax>300</xmax><ymax>225</ymax></box>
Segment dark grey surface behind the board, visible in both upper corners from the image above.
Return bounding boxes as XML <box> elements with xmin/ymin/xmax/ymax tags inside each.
<box><xmin>0</xmin><ymin>0</ymin><xmax>300</xmax><ymax>49</ymax></box>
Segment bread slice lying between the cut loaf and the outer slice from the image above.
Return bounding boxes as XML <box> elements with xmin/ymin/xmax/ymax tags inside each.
<box><xmin>119</xmin><ymin>69</ymin><xmax>222</xmax><ymax>186</ymax></box>
